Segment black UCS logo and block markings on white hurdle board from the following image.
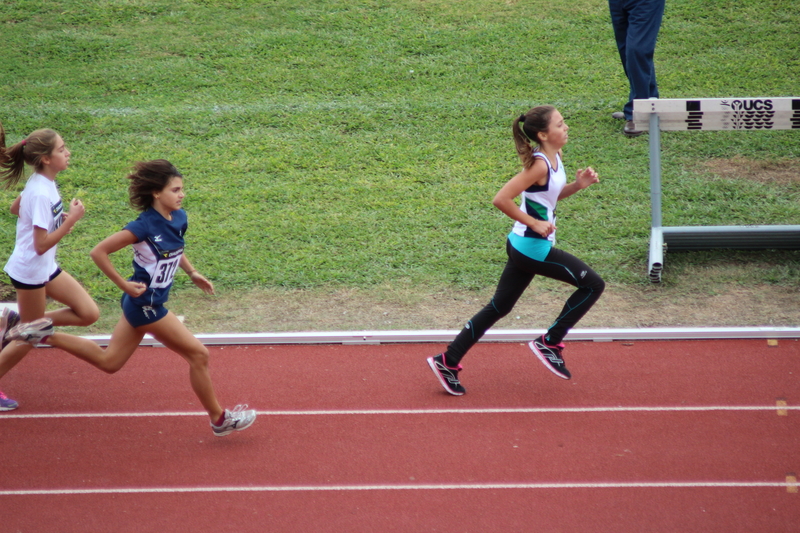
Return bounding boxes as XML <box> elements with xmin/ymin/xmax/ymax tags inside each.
<box><xmin>686</xmin><ymin>98</ymin><xmax>800</xmax><ymax>130</ymax></box>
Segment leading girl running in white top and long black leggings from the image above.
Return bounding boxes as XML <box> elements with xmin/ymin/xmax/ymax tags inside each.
<box><xmin>428</xmin><ymin>106</ymin><xmax>605</xmax><ymax>396</ymax></box>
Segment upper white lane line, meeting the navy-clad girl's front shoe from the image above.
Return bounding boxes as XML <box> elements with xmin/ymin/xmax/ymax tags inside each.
<box><xmin>0</xmin><ymin>405</ymin><xmax>800</xmax><ymax>420</ymax></box>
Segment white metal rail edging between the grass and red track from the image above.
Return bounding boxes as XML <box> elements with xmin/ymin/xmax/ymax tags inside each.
<box><xmin>75</xmin><ymin>327</ymin><xmax>800</xmax><ymax>346</ymax></box>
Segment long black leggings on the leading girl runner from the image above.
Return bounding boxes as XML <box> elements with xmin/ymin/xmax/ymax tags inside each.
<box><xmin>445</xmin><ymin>242</ymin><xmax>606</xmax><ymax>367</ymax></box>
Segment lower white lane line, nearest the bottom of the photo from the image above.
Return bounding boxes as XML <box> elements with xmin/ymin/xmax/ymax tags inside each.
<box><xmin>0</xmin><ymin>481</ymin><xmax>790</xmax><ymax>496</ymax></box>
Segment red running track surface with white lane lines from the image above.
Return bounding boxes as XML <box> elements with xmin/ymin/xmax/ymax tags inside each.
<box><xmin>0</xmin><ymin>339</ymin><xmax>800</xmax><ymax>533</ymax></box>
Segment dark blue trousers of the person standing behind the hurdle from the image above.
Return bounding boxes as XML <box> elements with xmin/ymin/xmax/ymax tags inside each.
<box><xmin>608</xmin><ymin>0</ymin><xmax>666</xmax><ymax>120</ymax></box>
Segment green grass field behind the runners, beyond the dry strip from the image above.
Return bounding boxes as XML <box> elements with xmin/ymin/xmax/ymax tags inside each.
<box><xmin>0</xmin><ymin>0</ymin><xmax>800</xmax><ymax>308</ymax></box>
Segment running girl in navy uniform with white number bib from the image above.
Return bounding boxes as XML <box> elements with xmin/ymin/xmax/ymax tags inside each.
<box><xmin>8</xmin><ymin>159</ymin><xmax>256</xmax><ymax>436</ymax></box>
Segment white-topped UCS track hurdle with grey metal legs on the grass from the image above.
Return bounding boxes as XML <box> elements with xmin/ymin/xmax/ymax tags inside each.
<box><xmin>633</xmin><ymin>97</ymin><xmax>800</xmax><ymax>283</ymax></box>
